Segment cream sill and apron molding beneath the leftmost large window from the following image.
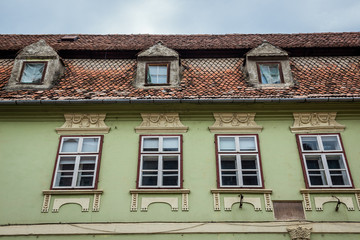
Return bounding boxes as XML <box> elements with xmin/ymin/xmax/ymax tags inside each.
<box><xmin>41</xmin><ymin>189</ymin><xmax>103</xmax><ymax>213</ymax></box>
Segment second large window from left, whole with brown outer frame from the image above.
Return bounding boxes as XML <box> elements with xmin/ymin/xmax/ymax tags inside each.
<box><xmin>137</xmin><ymin>135</ymin><xmax>182</xmax><ymax>189</ymax></box>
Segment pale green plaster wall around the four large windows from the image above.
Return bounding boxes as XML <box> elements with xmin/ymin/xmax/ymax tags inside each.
<box><xmin>0</xmin><ymin>103</ymin><xmax>360</xmax><ymax>225</ymax></box>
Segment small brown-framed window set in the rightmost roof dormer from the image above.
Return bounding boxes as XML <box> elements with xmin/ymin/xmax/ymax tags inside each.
<box><xmin>257</xmin><ymin>62</ymin><xmax>284</xmax><ymax>84</ymax></box>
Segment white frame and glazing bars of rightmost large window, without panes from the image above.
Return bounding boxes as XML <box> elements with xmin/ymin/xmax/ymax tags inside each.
<box><xmin>298</xmin><ymin>134</ymin><xmax>352</xmax><ymax>188</ymax></box>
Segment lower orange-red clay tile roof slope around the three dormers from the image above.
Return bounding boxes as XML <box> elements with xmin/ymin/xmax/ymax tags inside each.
<box><xmin>0</xmin><ymin>56</ymin><xmax>360</xmax><ymax>101</ymax></box>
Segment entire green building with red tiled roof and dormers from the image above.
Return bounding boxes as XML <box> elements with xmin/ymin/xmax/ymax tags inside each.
<box><xmin>0</xmin><ymin>33</ymin><xmax>360</xmax><ymax>240</ymax></box>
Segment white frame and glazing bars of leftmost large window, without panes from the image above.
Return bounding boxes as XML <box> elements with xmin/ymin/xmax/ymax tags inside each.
<box><xmin>52</xmin><ymin>136</ymin><xmax>102</xmax><ymax>189</ymax></box>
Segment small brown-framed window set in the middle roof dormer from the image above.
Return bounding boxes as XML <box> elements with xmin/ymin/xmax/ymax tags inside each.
<box><xmin>146</xmin><ymin>63</ymin><xmax>169</xmax><ymax>85</ymax></box>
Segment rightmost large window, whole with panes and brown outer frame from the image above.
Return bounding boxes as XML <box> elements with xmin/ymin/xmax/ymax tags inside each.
<box><xmin>296</xmin><ymin>133</ymin><xmax>353</xmax><ymax>188</ymax></box>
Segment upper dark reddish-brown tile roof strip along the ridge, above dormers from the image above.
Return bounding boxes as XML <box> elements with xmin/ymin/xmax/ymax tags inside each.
<box><xmin>0</xmin><ymin>32</ymin><xmax>360</xmax><ymax>51</ymax></box>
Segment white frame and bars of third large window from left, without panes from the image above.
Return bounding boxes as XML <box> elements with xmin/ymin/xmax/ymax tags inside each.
<box><xmin>216</xmin><ymin>134</ymin><xmax>263</xmax><ymax>188</ymax></box>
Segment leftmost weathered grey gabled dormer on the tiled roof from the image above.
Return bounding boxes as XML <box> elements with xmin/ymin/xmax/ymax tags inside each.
<box><xmin>6</xmin><ymin>40</ymin><xmax>65</xmax><ymax>90</ymax></box>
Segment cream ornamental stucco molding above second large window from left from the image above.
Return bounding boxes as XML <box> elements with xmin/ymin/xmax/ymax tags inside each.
<box><xmin>135</xmin><ymin>113</ymin><xmax>188</xmax><ymax>133</ymax></box>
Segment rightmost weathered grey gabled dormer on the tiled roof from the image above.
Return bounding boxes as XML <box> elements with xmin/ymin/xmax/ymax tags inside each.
<box><xmin>244</xmin><ymin>41</ymin><xmax>294</xmax><ymax>88</ymax></box>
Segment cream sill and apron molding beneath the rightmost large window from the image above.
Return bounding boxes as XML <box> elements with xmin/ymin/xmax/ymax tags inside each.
<box><xmin>300</xmin><ymin>188</ymin><xmax>360</xmax><ymax>211</ymax></box>
